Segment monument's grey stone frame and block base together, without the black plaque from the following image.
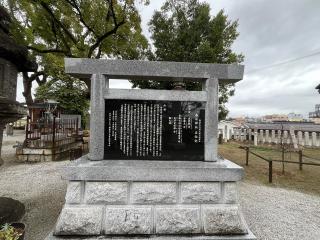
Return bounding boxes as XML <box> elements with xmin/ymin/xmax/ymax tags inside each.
<box><xmin>46</xmin><ymin>59</ymin><xmax>256</xmax><ymax>240</ymax></box>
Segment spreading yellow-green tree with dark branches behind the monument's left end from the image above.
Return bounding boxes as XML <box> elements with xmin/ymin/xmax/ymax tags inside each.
<box><xmin>1</xmin><ymin>0</ymin><xmax>148</xmax><ymax>104</ymax></box>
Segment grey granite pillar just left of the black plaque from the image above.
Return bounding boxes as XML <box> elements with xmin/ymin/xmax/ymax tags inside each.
<box><xmin>89</xmin><ymin>74</ymin><xmax>109</xmax><ymax>160</ymax></box>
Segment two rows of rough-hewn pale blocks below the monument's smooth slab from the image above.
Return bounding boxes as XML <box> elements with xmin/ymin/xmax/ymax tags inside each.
<box><xmin>54</xmin><ymin>181</ymin><xmax>247</xmax><ymax>235</ymax></box>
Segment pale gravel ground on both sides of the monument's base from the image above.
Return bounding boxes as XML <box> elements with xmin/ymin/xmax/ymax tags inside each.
<box><xmin>0</xmin><ymin>132</ymin><xmax>320</xmax><ymax>240</ymax></box>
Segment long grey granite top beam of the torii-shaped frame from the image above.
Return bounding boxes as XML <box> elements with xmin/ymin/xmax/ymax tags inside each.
<box><xmin>65</xmin><ymin>58</ymin><xmax>244</xmax><ymax>83</ymax></box>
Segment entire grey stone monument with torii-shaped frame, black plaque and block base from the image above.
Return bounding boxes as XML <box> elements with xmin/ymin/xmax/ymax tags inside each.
<box><xmin>47</xmin><ymin>58</ymin><xmax>255</xmax><ymax>240</ymax></box>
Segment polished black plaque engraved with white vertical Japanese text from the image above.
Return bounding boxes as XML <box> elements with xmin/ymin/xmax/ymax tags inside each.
<box><xmin>104</xmin><ymin>99</ymin><xmax>205</xmax><ymax>161</ymax></box>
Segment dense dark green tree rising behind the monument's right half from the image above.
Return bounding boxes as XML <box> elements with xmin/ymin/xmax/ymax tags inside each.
<box><xmin>133</xmin><ymin>0</ymin><xmax>243</xmax><ymax>119</ymax></box>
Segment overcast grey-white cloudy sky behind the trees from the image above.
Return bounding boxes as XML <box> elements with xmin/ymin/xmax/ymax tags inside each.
<box><xmin>18</xmin><ymin>0</ymin><xmax>320</xmax><ymax>117</ymax></box>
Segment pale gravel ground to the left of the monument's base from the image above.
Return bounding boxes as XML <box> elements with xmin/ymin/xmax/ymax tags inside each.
<box><xmin>0</xmin><ymin>132</ymin><xmax>68</xmax><ymax>240</ymax></box>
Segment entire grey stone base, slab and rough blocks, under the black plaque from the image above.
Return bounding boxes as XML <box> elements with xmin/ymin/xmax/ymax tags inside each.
<box><xmin>49</xmin><ymin>160</ymin><xmax>254</xmax><ymax>240</ymax></box>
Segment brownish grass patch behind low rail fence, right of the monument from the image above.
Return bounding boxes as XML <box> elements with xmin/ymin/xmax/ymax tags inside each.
<box><xmin>218</xmin><ymin>142</ymin><xmax>320</xmax><ymax>195</ymax></box>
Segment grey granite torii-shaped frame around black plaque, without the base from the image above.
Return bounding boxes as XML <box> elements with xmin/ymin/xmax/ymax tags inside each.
<box><xmin>65</xmin><ymin>58</ymin><xmax>244</xmax><ymax>161</ymax></box>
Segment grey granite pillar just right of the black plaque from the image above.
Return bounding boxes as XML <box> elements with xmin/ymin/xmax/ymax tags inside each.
<box><xmin>204</xmin><ymin>78</ymin><xmax>219</xmax><ymax>162</ymax></box>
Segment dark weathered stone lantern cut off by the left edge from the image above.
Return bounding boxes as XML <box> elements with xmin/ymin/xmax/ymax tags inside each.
<box><xmin>0</xmin><ymin>6</ymin><xmax>37</xmax><ymax>162</ymax></box>
